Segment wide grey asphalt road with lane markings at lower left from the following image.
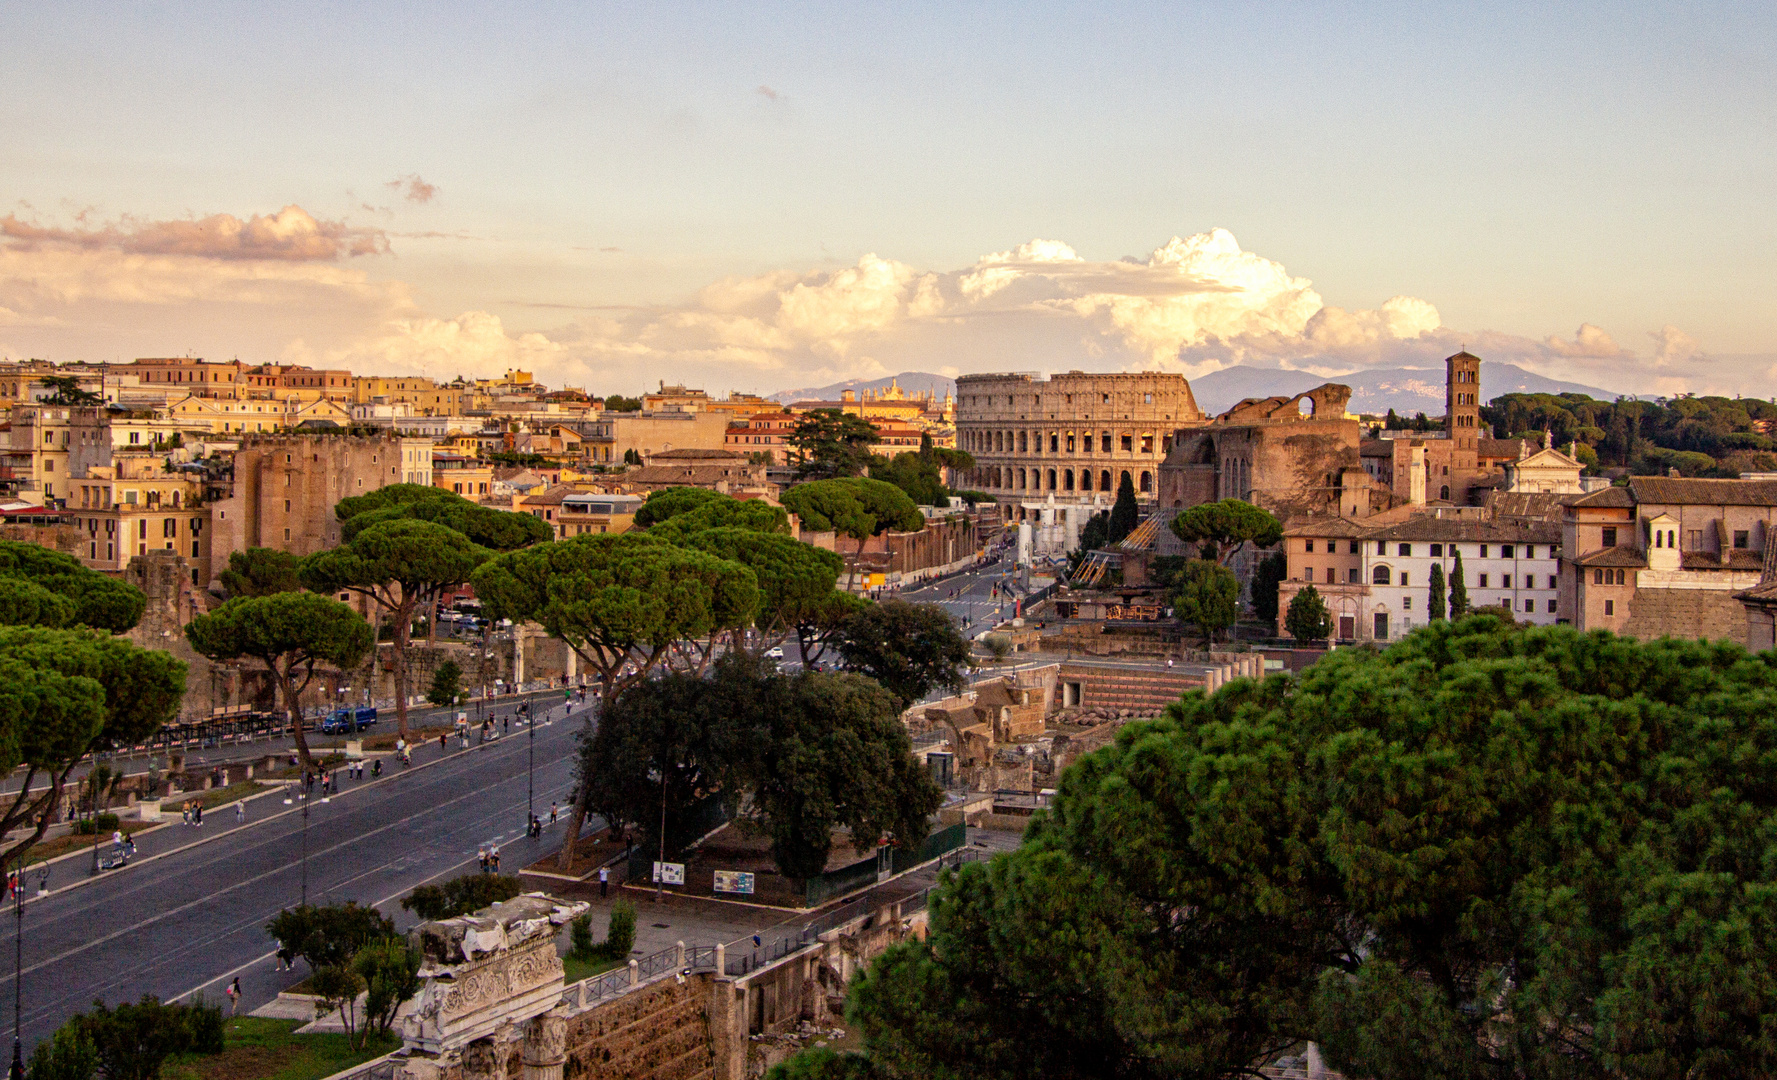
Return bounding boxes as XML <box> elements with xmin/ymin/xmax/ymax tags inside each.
<box><xmin>0</xmin><ymin>699</ymin><xmax>588</xmax><ymax>1048</ymax></box>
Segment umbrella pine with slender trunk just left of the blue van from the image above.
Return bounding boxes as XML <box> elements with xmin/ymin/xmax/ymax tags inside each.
<box><xmin>185</xmin><ymin>593</ymin><xmax>377</xmax><ymax>771</ymax></box>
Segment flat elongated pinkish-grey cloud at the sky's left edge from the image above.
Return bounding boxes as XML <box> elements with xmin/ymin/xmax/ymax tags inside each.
<box><xmin>0</xmin><ymin>204</ymin><xmax>389</xmax><ymax>263</ymax></box>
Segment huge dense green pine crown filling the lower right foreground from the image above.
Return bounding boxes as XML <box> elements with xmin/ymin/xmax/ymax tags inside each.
<box><xmin>851</xmin><ymin>615</ymin><xmax>1777</xmax><ymax>1080</ymax></box>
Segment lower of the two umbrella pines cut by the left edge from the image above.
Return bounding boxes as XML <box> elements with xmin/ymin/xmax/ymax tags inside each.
<box><xmin>0</xmin><ymin>627</ymin><xmax>185</xmax><ymax>869</ymax></box>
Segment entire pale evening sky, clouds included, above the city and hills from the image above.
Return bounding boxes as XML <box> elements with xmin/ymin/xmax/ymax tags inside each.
<box><xmin>0</xmin><ymin>0</ymin><xmax>1777</xmax><ymax>396</ymax></box>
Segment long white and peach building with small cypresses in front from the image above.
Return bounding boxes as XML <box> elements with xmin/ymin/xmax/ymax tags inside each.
<box><xmin>1278</xmin><ymin>513</ymin><xmax>1562</xmax><ymax>641</ymax></box>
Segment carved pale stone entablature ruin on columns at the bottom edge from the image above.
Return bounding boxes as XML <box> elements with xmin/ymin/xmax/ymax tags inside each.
<box><xmin>394</xmin><ymin>893</ymin><xmax>586</xmax><ymax>1080</ymax></box>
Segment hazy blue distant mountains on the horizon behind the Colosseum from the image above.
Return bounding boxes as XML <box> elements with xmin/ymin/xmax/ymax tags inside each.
<box><xmin>771</xmin><ymin>361</ymin><xmax>1619</xmax><ymax>416</ymax></box>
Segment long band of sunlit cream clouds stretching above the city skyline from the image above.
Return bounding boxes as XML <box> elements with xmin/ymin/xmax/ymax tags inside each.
<box><xmin>0</xmin><ymin>211</ymin><xmax>1768</xmax><ymax>393</ymax></box>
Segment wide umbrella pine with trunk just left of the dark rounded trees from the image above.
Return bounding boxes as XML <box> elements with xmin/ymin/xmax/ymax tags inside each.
<box><xmin>474</xmin><ymin>531</ymin><xmax>759</xmax><ymax>867</ymax></box>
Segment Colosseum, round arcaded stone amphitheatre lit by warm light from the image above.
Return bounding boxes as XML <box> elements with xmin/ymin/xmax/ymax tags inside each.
<box><xmin>956</xmin><ymin>371</ymin><xmax>1205</xmax><ymax>506</ymax></box>
